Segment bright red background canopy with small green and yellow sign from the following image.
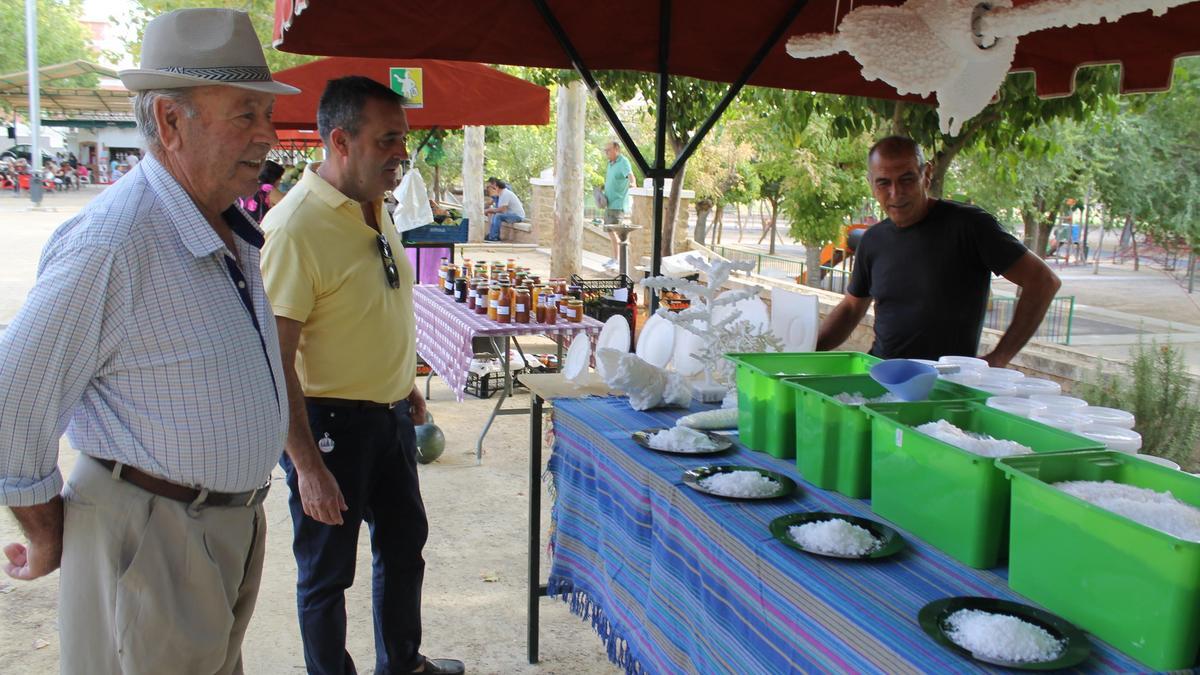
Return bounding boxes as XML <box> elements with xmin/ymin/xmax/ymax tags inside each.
<box><xmin>274</xmin><ymin>56</ymin><xmax>550</xmax><ymax>130</ymax></box>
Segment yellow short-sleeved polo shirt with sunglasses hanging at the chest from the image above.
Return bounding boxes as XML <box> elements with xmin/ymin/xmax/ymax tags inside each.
<box><xmin>262</xmin><ymin>163</ymin><xmax>416</xmax><ymax>404</ymax></box>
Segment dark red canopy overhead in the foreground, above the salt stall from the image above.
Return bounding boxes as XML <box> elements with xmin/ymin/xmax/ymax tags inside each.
<box><xmin>275</xmin><ymin>0</ymin><xmax>1200</xmax><ymax>101</ymax></box>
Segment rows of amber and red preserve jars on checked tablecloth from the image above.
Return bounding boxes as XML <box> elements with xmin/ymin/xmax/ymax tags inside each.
<box><xmin>455</xmin><ymin>277</ymin><xmax>583</xmax><ymax>324</ymax></box>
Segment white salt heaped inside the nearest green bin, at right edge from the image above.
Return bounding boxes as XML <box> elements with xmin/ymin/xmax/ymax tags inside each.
<box><xmin>1054</xmin><ymin>480</ymin><xmax>1200</xmax><ymax>542</ymax></box>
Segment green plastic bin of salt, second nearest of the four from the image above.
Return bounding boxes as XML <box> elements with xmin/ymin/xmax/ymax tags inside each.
<box><xmin>863</xmin><ymin>401</ymin><xmax>1104</xmax><ymax>569</ymax></box>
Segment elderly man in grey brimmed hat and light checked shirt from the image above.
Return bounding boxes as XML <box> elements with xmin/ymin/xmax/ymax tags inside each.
<box><xmin>0</xmin><ymin>10</ymin><xmax>298</xmax><ymax>675</ymax></box>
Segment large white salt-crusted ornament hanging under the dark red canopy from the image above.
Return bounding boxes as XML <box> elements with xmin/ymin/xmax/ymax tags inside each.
<box><xmin>787</xmin><ymin>0</ymin><xmax>1194</xmax><ymax>136</ymax></box>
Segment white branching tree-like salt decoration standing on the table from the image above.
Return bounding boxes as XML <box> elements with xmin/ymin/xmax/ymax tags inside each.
<box><xmin>642</xmin><ymin>256</ymin><xmax>784</xmax><ymax>387</ymax></box>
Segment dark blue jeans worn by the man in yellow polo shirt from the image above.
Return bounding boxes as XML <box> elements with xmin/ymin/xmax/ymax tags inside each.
<box><xmin>280</xmin><ymin>401</ymin><xmax>428</xmax><ymax>675</ymax></box>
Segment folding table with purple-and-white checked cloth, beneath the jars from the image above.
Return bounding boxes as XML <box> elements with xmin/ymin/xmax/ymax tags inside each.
<box><xmin>413</xmin><ymin>281</ymin><xmax>604</xmax><ymax>462</ymax></box>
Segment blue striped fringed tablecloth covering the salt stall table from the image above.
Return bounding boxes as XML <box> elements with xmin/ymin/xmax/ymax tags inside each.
<box><xmin>550</xmin><ymin>398</ymin><xmax>1166</xmax><ymax>674</ymax></box>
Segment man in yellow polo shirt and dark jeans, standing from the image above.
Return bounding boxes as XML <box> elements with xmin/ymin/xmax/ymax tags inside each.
<box><xmin>262</xmin><ymin>77</ymin><xmax>463</xmax><ymax>674</ymax></box>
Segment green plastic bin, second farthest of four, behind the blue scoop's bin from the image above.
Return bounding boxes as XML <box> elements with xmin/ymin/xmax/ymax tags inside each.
<box><xmin>784</xmin><ymin>375</ymin><xmax>990</xmax><ymax>500</ymax></box>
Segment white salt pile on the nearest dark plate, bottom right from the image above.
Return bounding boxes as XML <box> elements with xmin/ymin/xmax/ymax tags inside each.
<box><xmin>946</xmin><ymin>609</ymin><xmax>1066</xmax><ymax>663</ymax></box>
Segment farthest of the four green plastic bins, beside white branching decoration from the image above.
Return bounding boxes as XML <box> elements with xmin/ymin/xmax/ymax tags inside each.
<box><xmin>725</xmin><ymin>352</ymin><xmax>880</xmax><ymax>459</ymax></box>
